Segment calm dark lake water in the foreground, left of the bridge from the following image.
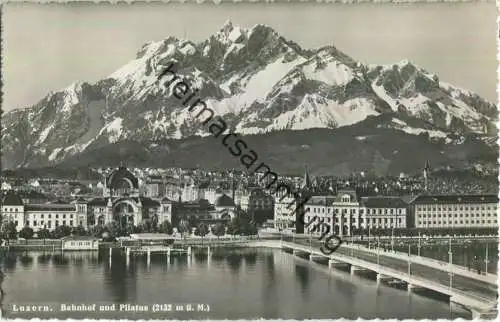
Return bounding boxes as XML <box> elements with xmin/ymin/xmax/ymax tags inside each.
<box><xmin>0</xmin><ymin>248</ymin><xmax>471</xmax><ymax>319</ymax></box>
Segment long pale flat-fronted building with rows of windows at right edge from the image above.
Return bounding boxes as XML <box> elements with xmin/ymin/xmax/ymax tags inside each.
<box><xmin>411</xmin><ymin>195</ymin><xmax>498</xmax><ymax>228</ymax></box>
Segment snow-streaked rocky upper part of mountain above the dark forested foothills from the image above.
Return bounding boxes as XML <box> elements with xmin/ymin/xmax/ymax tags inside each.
<box><xmin>1</xmin><ymin>22</ymin><xmax>498</xmax><ymax>174</ymax></box>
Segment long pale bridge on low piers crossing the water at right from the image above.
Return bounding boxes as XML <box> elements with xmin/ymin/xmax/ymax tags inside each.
<box><xmin>253</xmin><ymin>240</ymin><xmax>497</xmax><ymax>318</ymax></box>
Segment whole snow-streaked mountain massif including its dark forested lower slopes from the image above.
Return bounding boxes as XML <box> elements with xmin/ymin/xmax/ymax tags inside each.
<box><xmin>1</xmin><ymin>21</ymin><xmax>498</xmax><ymax>175</ymax></box>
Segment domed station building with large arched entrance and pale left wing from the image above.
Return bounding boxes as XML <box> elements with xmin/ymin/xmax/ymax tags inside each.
<box><xmin>0</xmin><ymin>167</ymin><xmax>172</xmax><ymax>232</ymax></box>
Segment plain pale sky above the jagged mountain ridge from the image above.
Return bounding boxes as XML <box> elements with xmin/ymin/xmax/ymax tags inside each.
<box><xmin>2</xmin><ymin>1</ymin><xmax>497</xmax><ymax>110</ymax></box>
